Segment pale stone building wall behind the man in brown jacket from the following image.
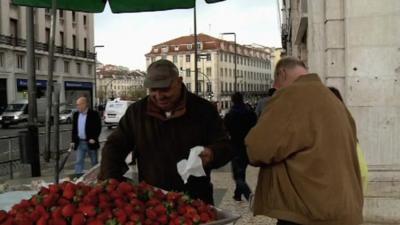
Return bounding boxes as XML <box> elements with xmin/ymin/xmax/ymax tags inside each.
<box><xmin>281</xmin><ymin>0</ymin><xmax>400</xmax><ymax>221</ymax></box>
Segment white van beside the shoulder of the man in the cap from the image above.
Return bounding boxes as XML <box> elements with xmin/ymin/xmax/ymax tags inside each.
<box><xmin>104</xmin><ymin>98</ymin><xmax>133</xmax><ymax>129</ymax></box>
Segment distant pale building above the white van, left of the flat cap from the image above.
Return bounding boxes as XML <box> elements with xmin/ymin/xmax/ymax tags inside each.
<box><xmin>97</xmin><ymin>65</ymin><xmax>145</xmax><ymax>103</ymax></box>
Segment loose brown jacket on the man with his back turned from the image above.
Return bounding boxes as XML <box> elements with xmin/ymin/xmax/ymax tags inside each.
<box><xmin>246</xmin><ymin>74</ymin><xmax>363</xmax><ymax>225</ymax></box>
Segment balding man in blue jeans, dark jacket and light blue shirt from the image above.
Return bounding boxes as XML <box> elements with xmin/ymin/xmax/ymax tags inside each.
<box><xmin>71</xmin><ymin>97</ymin><xmax>101</xmax><ymax>175</ymax></box>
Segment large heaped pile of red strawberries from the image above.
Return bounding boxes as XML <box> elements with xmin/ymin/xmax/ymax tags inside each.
<box><xmin>0</xmin><ymin>179</ymin><xmax>217</xmax><ymax>225</ymax></box>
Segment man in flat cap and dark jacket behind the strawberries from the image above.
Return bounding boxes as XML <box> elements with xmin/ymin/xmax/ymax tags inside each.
<box><xmin>99</xmin><ymin>59</ymin><xmax>232</xmax><ymax>204</ymax></box>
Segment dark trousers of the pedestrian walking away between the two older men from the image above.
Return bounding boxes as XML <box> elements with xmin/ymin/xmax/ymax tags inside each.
<box><xmin>231</xmin><ymin>155</ymin><xmax>251</xmax><ymax>200</ymax></box>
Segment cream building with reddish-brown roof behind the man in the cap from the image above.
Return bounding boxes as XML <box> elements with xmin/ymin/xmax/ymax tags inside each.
<box><xmin>146</xmin><ymin>34</ymin><xmax>271</xmax><ymax>109</ymax></box>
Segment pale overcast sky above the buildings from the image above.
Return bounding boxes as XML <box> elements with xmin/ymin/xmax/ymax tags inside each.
<box><xmin>95</xmin><ymin>0</ymin><xmax>281</xmax><ymax>70</ymax></box>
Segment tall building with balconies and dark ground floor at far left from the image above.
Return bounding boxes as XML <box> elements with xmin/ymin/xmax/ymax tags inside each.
<box><xmin>0</xmin><ymin>0</ymin><xmax>95</xmax><ymax>109</ymax></box>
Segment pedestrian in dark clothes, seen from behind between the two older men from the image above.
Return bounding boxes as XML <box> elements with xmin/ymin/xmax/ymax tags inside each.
<box><xmin>224</xmin><ymin>92</ymin><xmax>257</xmax><ymax>201</ymax></box>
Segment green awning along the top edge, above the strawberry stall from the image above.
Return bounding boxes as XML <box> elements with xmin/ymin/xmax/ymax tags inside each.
<box><xmin>12</xmin><ymin>0</ymin><xmax>224</xmax><ymax>13</ymax></box>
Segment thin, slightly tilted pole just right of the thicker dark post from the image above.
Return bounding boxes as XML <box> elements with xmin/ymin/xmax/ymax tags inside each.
<box><xmin>44</xmin><ymin>0</ymin><xmax>57</xmax><ymax>162</ymax></box>
